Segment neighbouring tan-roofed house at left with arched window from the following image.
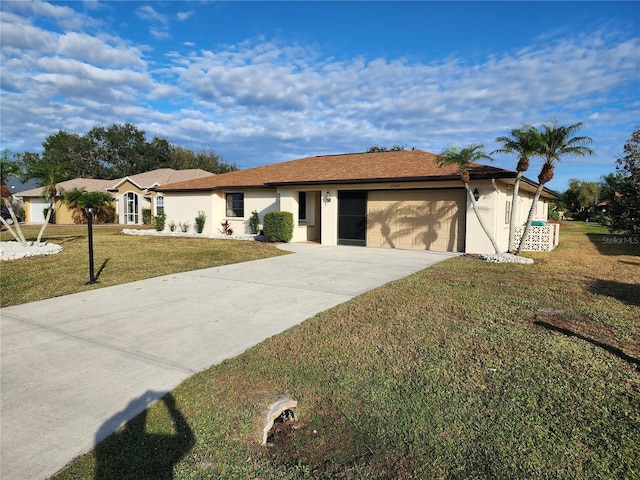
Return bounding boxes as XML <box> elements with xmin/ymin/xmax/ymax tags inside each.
<box><xmin>17</xmin><ymin>168</ymin><xmax>213</xmax><ymax>225</ymax></box>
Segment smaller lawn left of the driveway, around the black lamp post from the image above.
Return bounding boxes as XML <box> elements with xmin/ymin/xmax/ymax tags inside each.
<box><xmin>0</xmin><ymin>225</ymin><xmax>285</xmax><ymax>307</ymax></box>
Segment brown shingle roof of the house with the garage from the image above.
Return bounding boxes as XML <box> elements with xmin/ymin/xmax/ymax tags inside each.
<box><xmin>156</xmin><ymin>150</ymin><xmax>516</xmax><ymax>192</ymax></box>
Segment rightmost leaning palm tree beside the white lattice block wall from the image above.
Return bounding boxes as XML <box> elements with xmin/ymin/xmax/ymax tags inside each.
<box><xmin>516</xmin><ymin>120</ymin><xmax>593</xmax><ymax>255</ymax></box>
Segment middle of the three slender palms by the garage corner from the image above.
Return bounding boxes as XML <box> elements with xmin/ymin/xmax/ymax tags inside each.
<box><xmin>491</xmin><ymin>125</ymin><xmax>540</xmax><ymax>252</ymax></box>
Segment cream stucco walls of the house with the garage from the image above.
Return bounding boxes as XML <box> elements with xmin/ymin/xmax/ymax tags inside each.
<box><xmin>159</xmin><ymin>180</ymin><xmax>547</xmax><ymax>253</ymax></box>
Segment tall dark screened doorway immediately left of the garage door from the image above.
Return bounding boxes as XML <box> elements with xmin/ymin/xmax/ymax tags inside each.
<box><xmin>338</xmin><ymin>191</ymin><xmax>367</xmax><ymax>247</ymax></box>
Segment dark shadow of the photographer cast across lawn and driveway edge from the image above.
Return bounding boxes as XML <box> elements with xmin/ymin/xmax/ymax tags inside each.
<box><xmin>94</xmin><ymin>391</ymin><xmax>195</xmax><ymax>480</ymax></box>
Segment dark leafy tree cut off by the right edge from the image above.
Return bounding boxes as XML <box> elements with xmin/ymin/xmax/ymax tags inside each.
<box><xmin>607</xmin><ymin>127</ymin><xmax>640</xmax><ymax>234</ymax></box>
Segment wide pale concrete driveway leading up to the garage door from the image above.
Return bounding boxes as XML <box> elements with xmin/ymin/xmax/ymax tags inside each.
<box><xmin>0</xmin><ymin>244</ymin><xmax>455</xmax><ymax>480</ymax></box>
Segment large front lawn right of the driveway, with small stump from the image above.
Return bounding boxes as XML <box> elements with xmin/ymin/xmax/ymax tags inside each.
<box><xmin>6</xmin><ymin>223</ymin><xmax>640</xmax><ymax>479</ymax></box>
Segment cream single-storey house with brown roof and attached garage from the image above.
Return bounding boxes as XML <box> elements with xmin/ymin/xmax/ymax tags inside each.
<box><xmin>153</xmin><ymin>150</ymin><xmax>557</xmax><ymax>253</ymax></box>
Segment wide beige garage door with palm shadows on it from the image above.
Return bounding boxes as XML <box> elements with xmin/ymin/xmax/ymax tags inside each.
<box><xmin>367</xmin><ymin>189</ymin><xmax>467</xmax><ymax>252</ymax></box>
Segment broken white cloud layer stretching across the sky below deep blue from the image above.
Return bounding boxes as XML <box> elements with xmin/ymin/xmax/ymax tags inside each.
<box><xmin>0</xmin><ymin>3</ymin><xmax>640</xmax><ymax>190</ymax></box>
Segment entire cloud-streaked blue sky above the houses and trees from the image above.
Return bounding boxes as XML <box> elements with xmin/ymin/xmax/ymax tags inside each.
<box><xmin>0</xmin><ymin>0</ymin><xmax>640</xmax><ymax>191</ymax></box>
